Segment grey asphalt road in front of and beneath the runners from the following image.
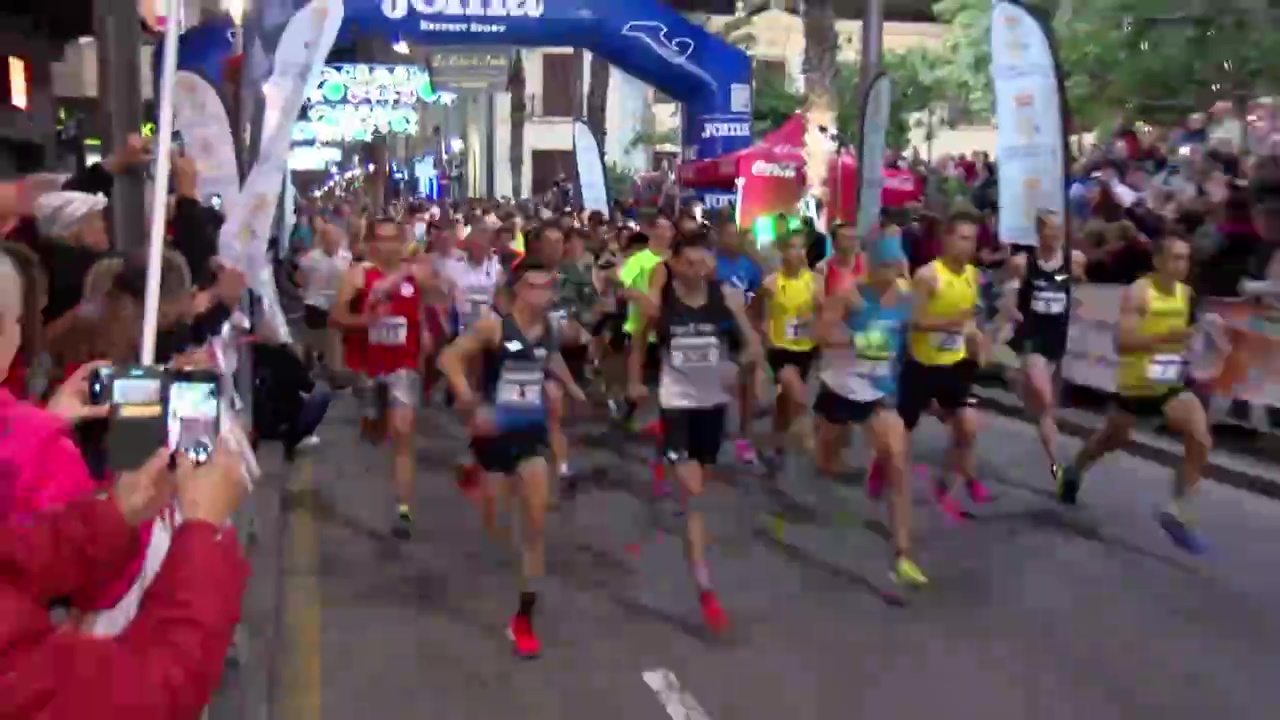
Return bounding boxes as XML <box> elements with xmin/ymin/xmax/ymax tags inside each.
<box><xmin>267</xmin><ymin>399</ymin><xmax>1280</xmax><ymax>720</ymax></box>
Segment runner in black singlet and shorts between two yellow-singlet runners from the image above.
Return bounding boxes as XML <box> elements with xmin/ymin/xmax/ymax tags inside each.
<box><xmin>997</xmin><ymin>211</ymin><xmax>1084</xmax><ymax>487</ymax></box>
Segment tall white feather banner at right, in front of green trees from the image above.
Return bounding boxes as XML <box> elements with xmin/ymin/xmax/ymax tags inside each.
<box><xmin>991</xmin><ymin>0</ymin><xmax>1066</xmax><ymax>245</ymax></box>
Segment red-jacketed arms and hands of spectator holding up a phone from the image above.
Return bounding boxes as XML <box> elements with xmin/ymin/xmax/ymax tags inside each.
<box><xmin>0</xmin><ymin>445</ymin><xmax>248</xmax><ymax>720</ymax></box>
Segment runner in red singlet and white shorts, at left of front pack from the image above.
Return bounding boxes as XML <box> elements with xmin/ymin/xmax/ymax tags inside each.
<box><xmin>333</xmin><ymin>218</ymin><xmax>436</xmax><ymax>539</ymax></box>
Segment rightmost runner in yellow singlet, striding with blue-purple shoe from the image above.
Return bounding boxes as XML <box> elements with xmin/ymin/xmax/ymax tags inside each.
<box><xmin>1059</xmin><ymin>234</ymin><xmax>1222</xmax><ymax>553</ymax></box>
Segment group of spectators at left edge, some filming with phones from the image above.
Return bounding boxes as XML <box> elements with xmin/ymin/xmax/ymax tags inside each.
<box><xmin>0</xmin><ymin>137</ymin><xmax>270</xmax><ymax>720</ymax></box>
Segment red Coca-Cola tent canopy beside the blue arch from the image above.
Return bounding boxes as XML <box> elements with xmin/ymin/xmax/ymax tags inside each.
<box><xmin>678</xmin><ymin>113</ymin><xmax>858</xmax><ymax>218</ymax></box>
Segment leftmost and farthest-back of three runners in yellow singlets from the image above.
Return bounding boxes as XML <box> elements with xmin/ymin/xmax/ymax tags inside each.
<box><xmin>760</xmin><ymin>233</ymin><xmax>822</xmax><ymax>460</ymax></box>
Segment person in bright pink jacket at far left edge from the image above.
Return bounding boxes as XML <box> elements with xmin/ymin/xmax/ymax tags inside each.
<box><xmin>0</xmin><ymin>240</ymin><xmax>150</xmax><ymax>614</ymax></box>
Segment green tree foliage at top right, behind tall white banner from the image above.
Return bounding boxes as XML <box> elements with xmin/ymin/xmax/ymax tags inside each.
<box><xmin>933</xmin><ymin>0</ymin><xmax>1280</xmax><ymax>131</ymax></box>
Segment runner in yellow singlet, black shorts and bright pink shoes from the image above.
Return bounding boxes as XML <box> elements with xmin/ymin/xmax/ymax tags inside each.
<box><xmin>897</xmin><ymin>206</ymin><xmax>991</xmax><ymax>520</ymax></box>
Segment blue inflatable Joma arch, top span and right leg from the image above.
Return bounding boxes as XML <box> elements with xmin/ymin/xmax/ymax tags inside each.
<box><xmin>343</xmin><ymin>0</ymin><xmax>751</xmax><ymax>160</ymax></box>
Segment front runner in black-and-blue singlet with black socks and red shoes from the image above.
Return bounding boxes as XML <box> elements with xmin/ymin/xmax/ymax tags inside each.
<box><xmin>440</xmin><ymin>259</ymin><xmax>586</xmax><ymax>657</ymax></box>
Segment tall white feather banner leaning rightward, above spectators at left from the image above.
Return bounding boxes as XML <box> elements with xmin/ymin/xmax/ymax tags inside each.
<box><xmin>218</xmin><ymin>0</ymin><xmax>343</xmax><ymax>340</ymax></box>
